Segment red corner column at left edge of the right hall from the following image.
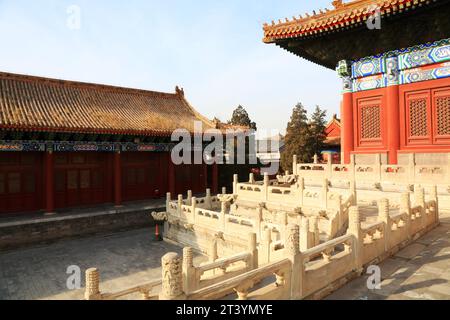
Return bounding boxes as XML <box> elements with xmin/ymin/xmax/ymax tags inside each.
<box><xmin>341</xmin><ymin>77</ymin><xmax>354</xmax><ymax>164</ymax></box>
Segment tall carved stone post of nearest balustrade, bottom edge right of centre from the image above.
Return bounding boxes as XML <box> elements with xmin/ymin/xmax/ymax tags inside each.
<box><xmin>284</xmin><ymin>224</ymin><xmax>304</xmax><ymax>300</ymax></box>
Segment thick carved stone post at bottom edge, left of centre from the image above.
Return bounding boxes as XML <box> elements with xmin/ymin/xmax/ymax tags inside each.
<box><xmin>159</xmin><ymin>252</ymin><xmax>186</xmax><ymax>300</ymax></box>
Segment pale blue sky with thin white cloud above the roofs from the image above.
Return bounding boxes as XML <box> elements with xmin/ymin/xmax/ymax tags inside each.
<box><xmin>0</xmin><ymin>0</ymin><xmax>341</xmax><ymax>136</ymax></box>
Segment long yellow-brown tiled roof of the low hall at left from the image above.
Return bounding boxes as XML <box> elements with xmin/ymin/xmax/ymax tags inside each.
<box><xmin>0</xmin><ymin>72</ymin><xmax>215</xmax><ymax>136</ymax></box>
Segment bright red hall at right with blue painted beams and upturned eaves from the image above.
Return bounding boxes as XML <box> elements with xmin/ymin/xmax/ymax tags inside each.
<box><xmin>264</xmin><ymin>0</ymin><xmax>450</xmax><ymax>164</ymax></box>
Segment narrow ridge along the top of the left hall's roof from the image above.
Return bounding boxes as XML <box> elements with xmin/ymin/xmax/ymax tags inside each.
<box><xmin>0</xmin><ymin>71</ymin><xmax>183</xmax><ymax>98</ymax></box>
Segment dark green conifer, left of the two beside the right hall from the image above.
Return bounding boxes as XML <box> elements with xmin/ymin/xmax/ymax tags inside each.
<box><xmin>281</xmin><ymin>103</ymin><xmax>311</xmax><ymax>171</ymax></box>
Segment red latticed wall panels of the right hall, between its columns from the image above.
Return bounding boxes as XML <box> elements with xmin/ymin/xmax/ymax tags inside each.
<box><xmin>353</xmin><ymin>78</ymin><xmax>450</xmax><ymax>158</ymax></box>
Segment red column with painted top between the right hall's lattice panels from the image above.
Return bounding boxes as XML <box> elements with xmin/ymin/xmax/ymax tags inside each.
<box><xmin>386</xmin><ymin>57</ymin><xmax>400</xmax><ymax>164</ymax></box>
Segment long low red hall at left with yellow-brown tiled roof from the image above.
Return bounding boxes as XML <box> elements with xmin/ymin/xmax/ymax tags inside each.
<box><xmin>0</xmin><ymin>73</ymin><xmax>217</xmax><ymax>214</ymax></box>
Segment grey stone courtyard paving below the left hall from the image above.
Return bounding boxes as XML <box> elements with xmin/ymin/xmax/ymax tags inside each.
<box><xmin>0</xmin><ymin>228</ymin><xmax>205</xmax><ymax>300</ymax></box>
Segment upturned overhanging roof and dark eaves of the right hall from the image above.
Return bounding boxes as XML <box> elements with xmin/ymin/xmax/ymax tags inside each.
<box><xmin>263</xmin><ymin>0</ymin><xmax>450</xmax><ymax>69</ymax></box>
